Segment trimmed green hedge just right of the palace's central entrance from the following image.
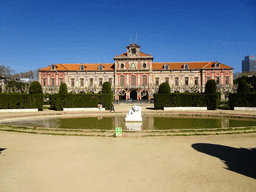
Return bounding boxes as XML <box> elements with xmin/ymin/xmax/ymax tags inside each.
<box><xmin>154</xmin><ymin>93</ymin><xmax>220</xmax><ymax>110</ymax></box>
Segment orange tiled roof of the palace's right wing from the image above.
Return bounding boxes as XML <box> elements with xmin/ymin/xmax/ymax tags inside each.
<box><xmin>152</xmin><ymin>61</ymin><xmax>232</xmax><ymax>70</ymax></box>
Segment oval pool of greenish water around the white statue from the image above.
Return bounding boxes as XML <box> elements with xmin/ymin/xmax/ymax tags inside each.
<box><xmin>3</xmin><ymin>116</ymin><xmax>256</xmax><ymax>130</ymax></box>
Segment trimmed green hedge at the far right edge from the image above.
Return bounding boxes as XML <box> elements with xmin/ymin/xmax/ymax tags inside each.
<box><xmin>229</xmin><ymin>93</ymin><xmax>256</xmax><ymax>109</ymax></box>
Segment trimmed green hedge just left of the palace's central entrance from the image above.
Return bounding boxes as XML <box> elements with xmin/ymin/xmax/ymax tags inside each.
<box><xmin>50</xmin><ymin>93</ymin><xmax>113</xmax><ymax>110</ymax></box>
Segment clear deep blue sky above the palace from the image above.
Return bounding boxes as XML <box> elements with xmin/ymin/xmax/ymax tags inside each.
<box><xmin>0</xmin><ymin>0</ymin><xmax>256</xmax><ymax>72</ymax></box>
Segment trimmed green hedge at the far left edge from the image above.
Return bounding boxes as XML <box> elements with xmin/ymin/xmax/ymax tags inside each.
<box><xmin>0</xmin><ymin>93</ymin><xmax>43</xmax><ymax>110</ymax></box>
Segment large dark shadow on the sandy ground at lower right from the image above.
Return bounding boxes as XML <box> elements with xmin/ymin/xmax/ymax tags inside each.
<box><xmin>192</xmin><ymin>143</ymin><xmax>256</xmax><ymax>179</ymax></box>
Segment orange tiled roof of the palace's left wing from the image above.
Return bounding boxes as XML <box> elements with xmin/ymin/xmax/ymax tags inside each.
<box><xmin>40</xmin><ymin>63</ymin><xmax>114</xmax><ymax>72</ymax></box>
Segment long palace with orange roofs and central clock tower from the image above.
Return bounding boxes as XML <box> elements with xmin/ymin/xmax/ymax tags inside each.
<box><xmin>39</xmin><ymin>43</ymin><xmax>233</xmax><ymax>100</ymax></box>
